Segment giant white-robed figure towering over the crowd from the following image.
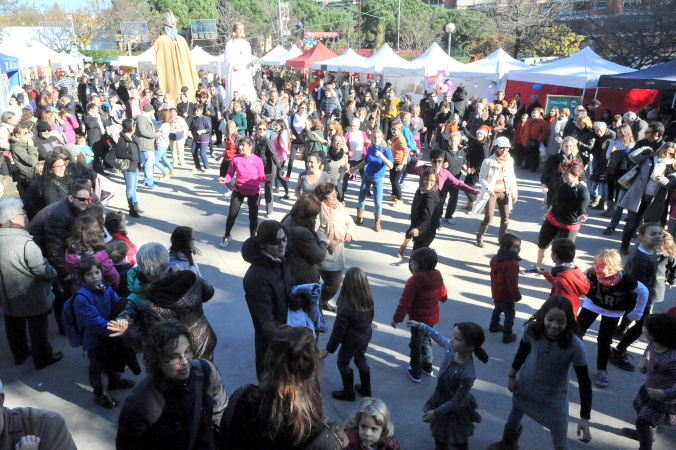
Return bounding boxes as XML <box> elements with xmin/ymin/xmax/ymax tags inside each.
<box><xmin>225</xmin><ymin>22</ymin><xmax>256</xmax><ymax>107</ymax></box>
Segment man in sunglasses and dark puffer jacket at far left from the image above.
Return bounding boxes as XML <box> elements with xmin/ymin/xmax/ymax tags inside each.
<box><xmin>27</xmin><ymin>183</ymin><xmax>91</xmax><ymax>334</ymax></box>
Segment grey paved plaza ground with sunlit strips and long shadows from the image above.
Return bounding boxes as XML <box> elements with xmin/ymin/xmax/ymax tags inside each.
<box><xmin>0</xmin><ymin>146</ymin><xmax>676</xmax><ymax>450</ymax></box>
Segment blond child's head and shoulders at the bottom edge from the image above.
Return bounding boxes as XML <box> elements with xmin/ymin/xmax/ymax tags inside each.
<box><xmin>345</xmin><ymin>397</ymin><xmax>401</xmax><ymax>450</ymax></box>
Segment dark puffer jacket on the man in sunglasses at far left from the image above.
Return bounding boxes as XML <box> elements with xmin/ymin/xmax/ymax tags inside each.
<box><xmin>27</xmin><ymin>198</ymin><xmax>82</xmax><ymax>280</ymax></box>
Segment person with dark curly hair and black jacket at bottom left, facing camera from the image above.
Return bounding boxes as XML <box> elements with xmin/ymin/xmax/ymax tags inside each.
<box><xmin>115</xmin><ymin>320</ymin><xmax>228</xmax><ymax>450</ymax></box>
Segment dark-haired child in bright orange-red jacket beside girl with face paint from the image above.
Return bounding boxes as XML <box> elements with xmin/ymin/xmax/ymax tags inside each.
<box><xmin>543</xmin><ymin>238</ymin><xmax>590</xmax><ymax>320</ymax></box>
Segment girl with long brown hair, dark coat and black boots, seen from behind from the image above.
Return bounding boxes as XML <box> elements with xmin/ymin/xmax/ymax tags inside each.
<box><xmin>326</xmin><ymin>267</ymin><xmax>374</xmax><ymax>402</ymax></box>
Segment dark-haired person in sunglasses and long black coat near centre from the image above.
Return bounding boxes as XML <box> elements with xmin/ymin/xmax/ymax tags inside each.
<box><xmin>242</xmin><ymin>220</ymin><xmax>296</xmax><ymax>381</ymax></box>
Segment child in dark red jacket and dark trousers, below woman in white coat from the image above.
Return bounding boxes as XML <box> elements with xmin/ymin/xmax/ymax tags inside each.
<box><xmin>488</xmin><ymin>233</ymin><xmax>521</xmax><ymax>344</ymax></box>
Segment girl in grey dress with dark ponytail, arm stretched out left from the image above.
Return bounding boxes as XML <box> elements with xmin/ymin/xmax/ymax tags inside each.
<box><xmin>406</xmin><ymin>320</ymin><xmax>488</xmax><ymax>450</ymax></box>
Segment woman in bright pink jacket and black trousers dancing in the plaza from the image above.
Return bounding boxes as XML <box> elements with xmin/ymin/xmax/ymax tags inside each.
<box><xmin>218</xmin><ymin>139</ymin><xmax>272</xmax><ymax>248</ymax></box>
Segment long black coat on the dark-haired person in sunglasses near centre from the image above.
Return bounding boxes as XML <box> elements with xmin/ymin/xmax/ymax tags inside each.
<box><xmin>242</xmin><ymin>238</ymin><xmax>296</xmax><ymax>348</ymax></box>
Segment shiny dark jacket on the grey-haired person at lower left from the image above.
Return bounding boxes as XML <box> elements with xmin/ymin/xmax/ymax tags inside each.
<box><xmin>144</xmin><ymin>270</ymin><xmax>216</xmax><ymax>360</ymax></box>
